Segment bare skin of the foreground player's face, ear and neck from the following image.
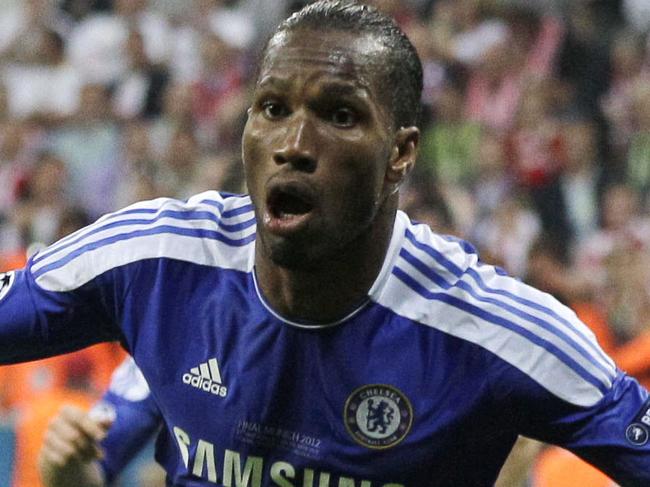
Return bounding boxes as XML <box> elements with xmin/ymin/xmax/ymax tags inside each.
<box><xmin>242</xmin><ymin>30</ymin><xmax>419</xmax><ymax>323</ymax></box>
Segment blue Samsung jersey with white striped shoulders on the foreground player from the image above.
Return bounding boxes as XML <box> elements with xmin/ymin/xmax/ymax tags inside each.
<box><xmin>0</xmin><ymin>192</ymin><xmax>650</xmax><ymax>487</ymax></box>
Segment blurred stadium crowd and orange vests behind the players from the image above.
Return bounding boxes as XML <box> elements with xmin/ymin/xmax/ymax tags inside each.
<box><xmin>0</xmin><ymin>0</ymin><xmax>650</xmax><ymax>487</ymax></box>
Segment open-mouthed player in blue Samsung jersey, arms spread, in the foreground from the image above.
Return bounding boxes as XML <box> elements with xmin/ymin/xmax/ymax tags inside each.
<box><xmin>0</xmin><ymin>1</ymin><xmax>650</xmax><ymax>487</ymax></box>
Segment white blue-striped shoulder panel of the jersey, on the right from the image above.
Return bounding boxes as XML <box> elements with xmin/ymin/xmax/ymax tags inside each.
<box><xmin>381</xmin><ymin>216</ymin><xmax>616</xmax><ymax>406</ymax></box>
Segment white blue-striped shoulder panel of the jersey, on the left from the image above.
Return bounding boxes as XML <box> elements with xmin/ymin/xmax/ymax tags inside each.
<box><xmin>29</xmin><ymin>191</ymin><xmax>255</xmax><ymax>291</ymax></box>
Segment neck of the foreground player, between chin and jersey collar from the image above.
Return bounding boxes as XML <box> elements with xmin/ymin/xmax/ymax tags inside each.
<box><xmin>255</xmin><ymin>198</ymin><xmax>396</xmax><ymax>324</ymax></box>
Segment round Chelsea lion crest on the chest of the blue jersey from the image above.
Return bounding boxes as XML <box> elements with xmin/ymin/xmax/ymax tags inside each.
<box><xmin>343</xmin><ymin>384</ymin><xmax>413</xmax><ymax>450</ymax></box>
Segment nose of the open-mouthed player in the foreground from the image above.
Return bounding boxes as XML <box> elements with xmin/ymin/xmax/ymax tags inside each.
<box><xmin>273</xmin><ymin>112</ymin><xmax>316</xmax><ymax>172</ymax></box>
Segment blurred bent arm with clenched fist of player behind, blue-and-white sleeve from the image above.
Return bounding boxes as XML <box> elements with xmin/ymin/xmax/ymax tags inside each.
<box><xmin>39</xmin><ymin>358</ymin><xmax>161</xmax><ymax>487</ymax></box>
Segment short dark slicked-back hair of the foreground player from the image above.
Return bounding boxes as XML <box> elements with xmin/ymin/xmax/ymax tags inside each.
<box><xmin>264</xmin><ymin>0</ymin><xmax>422</xmax><ymax>127</ymax></box>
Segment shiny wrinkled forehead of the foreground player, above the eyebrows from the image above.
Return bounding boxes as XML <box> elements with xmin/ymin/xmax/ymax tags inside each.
<box><xmin>258</xmin><ymin>29</ymin><xmax>386</xmax><ymax>97</ymax></box>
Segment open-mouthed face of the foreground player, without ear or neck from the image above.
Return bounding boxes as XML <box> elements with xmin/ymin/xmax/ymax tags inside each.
<box><xmin>243</xmin><ymin>30</ymin><xmax>395</xmax><ymax>268</ymax></box>
